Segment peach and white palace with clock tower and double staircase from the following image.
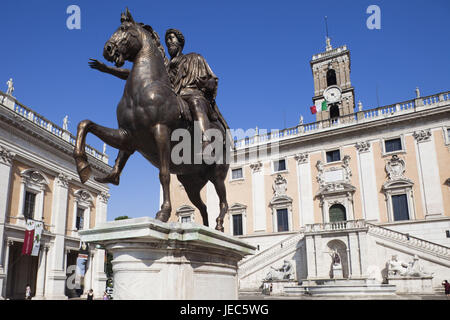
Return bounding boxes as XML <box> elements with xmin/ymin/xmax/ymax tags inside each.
<box><xmin>171</xmin><ymin>39</ymin><xmax>450</xmax><ymax>292</ymax></box>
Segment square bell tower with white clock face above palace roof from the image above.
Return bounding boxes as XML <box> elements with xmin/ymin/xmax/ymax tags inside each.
<box><xmin>310</xmin><ymin>36</ymin><xmax>355</xmax><ymax>122</ymax></box>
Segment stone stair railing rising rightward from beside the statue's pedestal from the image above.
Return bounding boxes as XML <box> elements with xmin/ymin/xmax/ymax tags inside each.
<box><xmin>238</xmin><ymin>232</ymin><xmax>305</xmax><ymax>278</ymax></box>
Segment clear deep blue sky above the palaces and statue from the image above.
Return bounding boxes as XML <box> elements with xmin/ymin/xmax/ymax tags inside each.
<box><xmin>0</xmin><ymin>0</ymin><xmax>450</xmax><ymax>220</ymax></box>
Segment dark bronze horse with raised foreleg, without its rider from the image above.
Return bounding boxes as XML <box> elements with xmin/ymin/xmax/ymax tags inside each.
<box><xmin>73</xmin><ymin>9</ymin><xmax>229</xmax><ymax>232</ymax></box>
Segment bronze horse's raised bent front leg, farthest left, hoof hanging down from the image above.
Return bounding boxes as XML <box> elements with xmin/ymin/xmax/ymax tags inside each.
<box><xmin>73</xmin><ymin>120</ymin><xmax>133</xmax><ymax>183</ymax></box>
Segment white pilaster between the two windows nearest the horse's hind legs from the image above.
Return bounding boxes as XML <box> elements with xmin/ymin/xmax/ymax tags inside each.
<box><xmin>250</xmin><ymin>161</ymin><xmax>267</xmax><ymax>232</ymax></box>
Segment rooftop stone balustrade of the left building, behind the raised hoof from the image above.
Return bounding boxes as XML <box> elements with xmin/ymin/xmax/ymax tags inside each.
<box><xmin>0</xmin><ymin>91</ymin><xmax>108</xmax><ymax>164</ymax></box>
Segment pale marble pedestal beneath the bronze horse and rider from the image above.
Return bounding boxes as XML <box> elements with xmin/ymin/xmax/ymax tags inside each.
<box><xmin>79</xmin><ymin>217</ymin><xmax>255</xmax><ymax>300</ymax></box>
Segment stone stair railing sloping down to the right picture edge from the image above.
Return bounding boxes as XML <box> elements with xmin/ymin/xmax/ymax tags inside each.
<box><xmin>366</xmin><ymin>222</ymin><xmax>450</xmax><ymax>260</ymax></box>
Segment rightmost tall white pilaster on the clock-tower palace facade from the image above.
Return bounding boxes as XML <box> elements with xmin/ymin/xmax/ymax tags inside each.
<box><xmin>410</xmin><ymin>129</ymin><xmax>444</xmax><ymax>218</ymax></box>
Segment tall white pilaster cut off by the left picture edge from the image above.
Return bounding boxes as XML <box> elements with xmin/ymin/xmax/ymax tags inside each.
<box><xmin>0</xmin><ymin>146</ymin><xmax>15</xmax><ymax>299</ymax></box>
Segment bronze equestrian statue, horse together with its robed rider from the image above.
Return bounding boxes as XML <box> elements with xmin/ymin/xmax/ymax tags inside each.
<box><xmin>73</xmin><ymin>9</ymin><xmax>230</xmax><ymax>232</ymax></box>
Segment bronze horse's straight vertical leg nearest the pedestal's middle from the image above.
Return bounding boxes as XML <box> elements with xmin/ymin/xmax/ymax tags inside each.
<box><xmin>153</xmin><ymin>124</ymin><xmax>172</xmax><ymax>222</ymax></box>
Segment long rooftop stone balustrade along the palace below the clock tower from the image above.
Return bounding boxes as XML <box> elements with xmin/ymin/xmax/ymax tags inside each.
<box><xmin>234</xmin><ymin>91</ymin><xmax>450</xmax><ymax>150</ymax></box>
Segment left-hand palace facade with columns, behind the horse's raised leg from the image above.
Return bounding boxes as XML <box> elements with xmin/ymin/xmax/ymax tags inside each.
<box><xmin>0</xmin><ymin>92</ymin><xmax>111</xmax><ymax>299</ymax></box>
